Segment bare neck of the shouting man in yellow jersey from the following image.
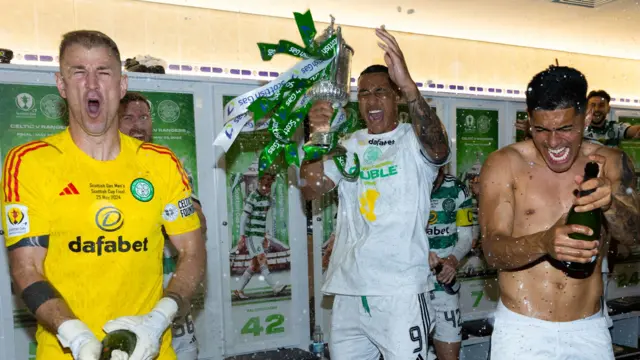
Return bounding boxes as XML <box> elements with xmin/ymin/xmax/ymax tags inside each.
<box><xmin>69</xmin><ymin>127</ymin><xmax>120</xmax><ymax>161</ymax></box>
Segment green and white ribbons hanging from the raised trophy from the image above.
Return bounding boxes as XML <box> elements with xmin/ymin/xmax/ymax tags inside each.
<box><xmin>214</xmin><ymin>11</ymin><xmax>359</xmax><ymax>178</ymax></box>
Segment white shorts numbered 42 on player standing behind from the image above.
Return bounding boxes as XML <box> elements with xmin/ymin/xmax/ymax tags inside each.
<box><xmin>431</xmin><ymin>291</ymin><xmax>462</xmax><ymax>343</ymax></box>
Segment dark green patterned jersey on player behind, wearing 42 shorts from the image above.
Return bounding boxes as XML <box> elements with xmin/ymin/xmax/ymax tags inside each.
<box><xmin>427</xmin><ymin>175</ymin><xmax>473</xmax><ymax>291</ymax></box>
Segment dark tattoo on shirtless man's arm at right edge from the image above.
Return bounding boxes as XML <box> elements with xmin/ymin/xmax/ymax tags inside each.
<box><xmin>605</xmin><ymin>153</ymin><xmax>640</xmax><ymax>245</ymax></box>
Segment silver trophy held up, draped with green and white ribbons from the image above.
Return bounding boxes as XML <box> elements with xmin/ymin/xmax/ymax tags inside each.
<box><xmin>305</xmin><ymin>15</ymin><xmax>353</xmax><ymax>154</ymax></box>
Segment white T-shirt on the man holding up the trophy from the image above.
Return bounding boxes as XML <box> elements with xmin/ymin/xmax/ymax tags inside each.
<box><xmin>323</xmin><ymin>124</ymin><xmax>450</xmax><ymax>296</ymax></box>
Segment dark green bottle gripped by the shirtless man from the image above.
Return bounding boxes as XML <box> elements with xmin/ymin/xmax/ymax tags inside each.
<box><xmin>564</xmin><ymin>161</ymin><xmax>602</xmax><ymax>275</ymax></box>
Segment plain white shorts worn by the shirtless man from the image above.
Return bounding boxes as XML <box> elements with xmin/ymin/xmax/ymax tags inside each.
<box><xmin>491</xmin><ymin>301</ymin><xmax>614</xmax><ymax>360</ymax></box>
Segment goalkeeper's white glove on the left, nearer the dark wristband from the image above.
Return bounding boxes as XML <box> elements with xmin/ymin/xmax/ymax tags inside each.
<box><xmin>58</xmin><ymin>319</ymin><xmax>101</xmax><ymax>360</ymax></box>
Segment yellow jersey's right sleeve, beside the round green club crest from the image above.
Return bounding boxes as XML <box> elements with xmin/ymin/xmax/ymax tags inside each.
<box><xmin>142</xmin><ymin>144</ymin><xmax>200</xmax><ymax>235</ymax></box>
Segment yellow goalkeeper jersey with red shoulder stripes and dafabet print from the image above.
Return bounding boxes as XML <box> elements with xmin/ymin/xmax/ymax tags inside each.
<box><xmin>1</xmin><ymin>129</ymin><xmax>200</xmax><ymax>360</ymax></box>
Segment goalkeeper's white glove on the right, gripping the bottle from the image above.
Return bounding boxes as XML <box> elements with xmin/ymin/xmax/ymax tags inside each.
<box><xmin>103</xmin><ymin>298</ymin><xmax>178</xmax><ymax>360</ymax></box>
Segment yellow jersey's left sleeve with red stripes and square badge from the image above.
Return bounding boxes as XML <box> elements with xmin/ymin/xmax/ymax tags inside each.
<box><xmin>0</xmin><ymin>141</ymin><xmax>50</xmax><ymax>249</ymax></box>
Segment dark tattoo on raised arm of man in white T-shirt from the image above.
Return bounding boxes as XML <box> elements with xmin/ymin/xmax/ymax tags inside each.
<box><xmin>408</xmin><ymin>96</ymin><xmax>450</xmax><ymax>164</ymax></box>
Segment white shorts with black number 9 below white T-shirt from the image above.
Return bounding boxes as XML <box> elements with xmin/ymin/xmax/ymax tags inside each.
<box><xmin>329</xmin><ymin>293</ymin><xmax>434</xmax><ymax>360</ymax></box>
